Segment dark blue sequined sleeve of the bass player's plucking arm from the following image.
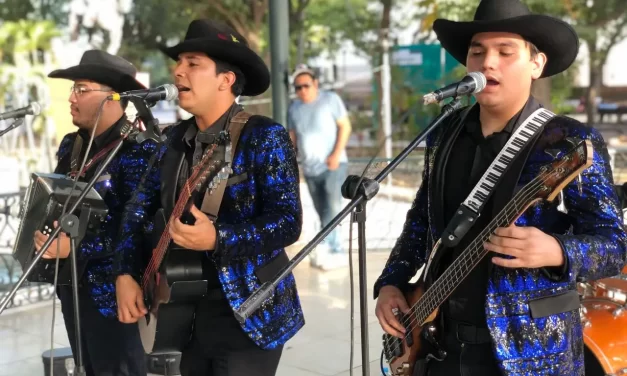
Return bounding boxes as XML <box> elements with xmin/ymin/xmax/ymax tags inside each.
<box><xmin>374</xmin><ymin>149</ymin><xmax>429</xmax><ymax>299</ymax></box>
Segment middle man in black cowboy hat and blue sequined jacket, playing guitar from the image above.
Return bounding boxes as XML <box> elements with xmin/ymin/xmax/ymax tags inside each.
<box><xmin>129</xmin><ymin>20</ymin><xmax>304</xmax><ymax>376</ymax></box>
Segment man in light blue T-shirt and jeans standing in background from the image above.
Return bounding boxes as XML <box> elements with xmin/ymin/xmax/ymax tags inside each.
<box><xmin>287</xmin><ymin>65</ymin><xmax>351</xmax><ymax>270</ymax></box>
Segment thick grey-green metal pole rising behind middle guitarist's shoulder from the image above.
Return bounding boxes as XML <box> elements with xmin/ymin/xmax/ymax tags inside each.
<box><xmin>270</xmin><ymin>0</ymin><xmax>289</xmax><ymax>125</ymax></box>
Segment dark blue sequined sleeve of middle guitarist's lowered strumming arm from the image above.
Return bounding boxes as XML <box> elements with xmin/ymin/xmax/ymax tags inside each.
<box><xmin>113</xmin><ymin>141</ymin><xmax>163</xmax><ymax>278</ymax></box>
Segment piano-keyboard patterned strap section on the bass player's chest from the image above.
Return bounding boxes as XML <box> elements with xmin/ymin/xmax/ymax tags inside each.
<box><xmin>464</xmin><ymin>108</ymin><xmax>555</xmax><ymax>213</ymax></box>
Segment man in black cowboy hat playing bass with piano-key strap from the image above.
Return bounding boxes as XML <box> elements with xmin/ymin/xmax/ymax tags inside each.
<box><xmin>375</xmin><ymin>0</ymin><xmax>627</xmax><ymax>376</ymax></box>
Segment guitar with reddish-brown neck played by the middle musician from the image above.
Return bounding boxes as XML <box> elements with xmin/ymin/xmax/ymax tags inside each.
<box><xmin>138</xmin><ymin>145</ymin><xmax>224</xmax><ymax>354</ymax></box>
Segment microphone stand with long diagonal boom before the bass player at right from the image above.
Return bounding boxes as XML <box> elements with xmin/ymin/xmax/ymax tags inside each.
<box><xmin>235</xmin><ymin>97</ymin><xmax>461</xmax><ymax>376</ymax></box>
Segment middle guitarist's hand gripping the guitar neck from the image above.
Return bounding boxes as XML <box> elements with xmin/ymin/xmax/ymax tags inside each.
<box><xmin>170</xmin><ymin>205</ymin><xmax>217</xmax><ymax>251</ymax></box>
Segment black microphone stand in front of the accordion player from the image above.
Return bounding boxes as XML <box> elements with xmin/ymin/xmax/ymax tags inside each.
<box><xmin>0</xmin><ymin>102</ymin><xmax>161</xmax><ymax>376</ymax></box>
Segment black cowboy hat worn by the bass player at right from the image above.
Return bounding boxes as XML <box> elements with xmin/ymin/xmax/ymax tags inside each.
<box><xmin>433</xmin><ymin>0</ymin><xmax>579</xmax><ymax>77</ymax></box>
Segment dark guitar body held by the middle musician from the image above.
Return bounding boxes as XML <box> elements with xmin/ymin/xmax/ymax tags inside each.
<box><xmin>138</xmin><ymin>209</ymin><xmax>207</xmax><ymax>354</ymax></box>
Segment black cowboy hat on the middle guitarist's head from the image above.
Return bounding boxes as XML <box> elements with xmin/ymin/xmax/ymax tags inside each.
<box><xmin>159</xmin><ymin>20</ymin><xmax>270</xmax><ymax>97</ymax></box>
